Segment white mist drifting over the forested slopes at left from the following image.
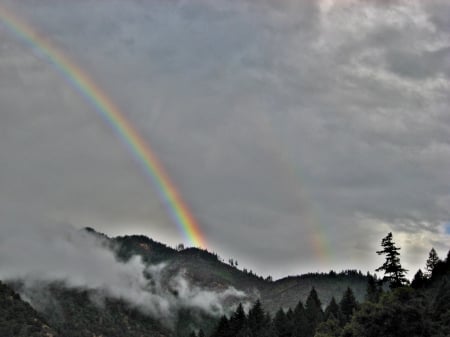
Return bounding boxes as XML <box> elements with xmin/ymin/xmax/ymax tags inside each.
<box><xmin>0</xmin><ymin>225</ymin><xmax>245</xmax><ymax>324</ymax></box>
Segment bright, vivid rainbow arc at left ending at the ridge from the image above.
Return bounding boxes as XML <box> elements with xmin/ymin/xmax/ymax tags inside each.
<box><xmin>0</xmin><ymin>5</ymin><xmax>206</xmax><ymax>248</ymax></box>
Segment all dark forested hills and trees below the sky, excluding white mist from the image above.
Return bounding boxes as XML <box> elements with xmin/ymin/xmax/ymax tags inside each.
<box><xmin>0</xmin><ymin>229</ymin><xmax>450</xmax><ymax>337</ymax></box>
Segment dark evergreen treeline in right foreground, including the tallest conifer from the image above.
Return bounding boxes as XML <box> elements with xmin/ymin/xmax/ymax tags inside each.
<box><xmin>189</xmin><ymin>233</ymin><xmax>450</xmax><ymax>337</ymax></box>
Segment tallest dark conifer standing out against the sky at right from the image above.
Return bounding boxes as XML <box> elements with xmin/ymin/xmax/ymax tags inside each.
<box><xmin>376</xmin><ymin>233</ymin><xmax>408</xmax><ymax>289</ymax></box>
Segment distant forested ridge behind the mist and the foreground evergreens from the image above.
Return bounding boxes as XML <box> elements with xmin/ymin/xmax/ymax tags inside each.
<box><xmin>110</xmin><ymin>229</ymin><xmax>367</xmax><ymax>313</ymax></box>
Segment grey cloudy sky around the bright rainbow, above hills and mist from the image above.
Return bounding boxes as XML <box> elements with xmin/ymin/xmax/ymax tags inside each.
<box><xmin>0</xmin><ymin>0</ymin><xmax>450</xmax><ymax>278</ymax></box>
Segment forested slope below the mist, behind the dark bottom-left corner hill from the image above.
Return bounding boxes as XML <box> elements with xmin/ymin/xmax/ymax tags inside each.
<box><xmin>12</xmin><ymin>283</ymin><xmax>173</xmax><ymax>337</ymax></box>
